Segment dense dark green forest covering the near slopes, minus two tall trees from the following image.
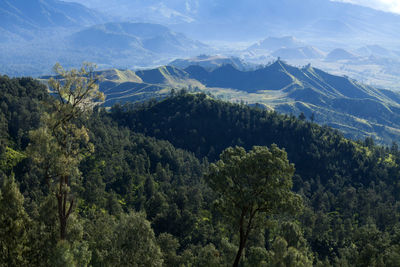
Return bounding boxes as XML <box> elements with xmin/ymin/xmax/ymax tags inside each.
<box><xmin>0</xmin><ymin>72</ymin><xmax>400</xmax><ymax>266</ymax></box>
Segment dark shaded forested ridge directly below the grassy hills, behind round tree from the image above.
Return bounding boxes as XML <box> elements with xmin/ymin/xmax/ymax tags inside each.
<box><xmin>107</xmin><ymin>94</ymin><xmax>400</xmax><ymax>265</ymax></box>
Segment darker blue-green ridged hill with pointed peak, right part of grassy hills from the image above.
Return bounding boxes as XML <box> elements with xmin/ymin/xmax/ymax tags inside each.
<box><xmin>181</xmin><ymin>60</ymin><xmax>400</xmax><ymax>143</ymax></box>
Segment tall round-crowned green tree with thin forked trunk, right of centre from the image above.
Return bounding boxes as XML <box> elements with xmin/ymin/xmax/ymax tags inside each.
<box><xmin>206</xmin><ymin>145</ymin><xmax>302</xmax><ymax>266</ymax></box>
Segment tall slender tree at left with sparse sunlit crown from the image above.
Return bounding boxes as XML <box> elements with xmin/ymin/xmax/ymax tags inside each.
<box><xmin>28</xmin><ymin>64</ymin><xmax>104</xmax><ymax>240</ymax></box>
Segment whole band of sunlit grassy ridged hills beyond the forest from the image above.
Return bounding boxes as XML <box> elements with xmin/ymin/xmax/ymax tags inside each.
<box><xmin>74</xmin><ymin>60</ymin><xmax>400</xmax><ymax>143</ymax></box>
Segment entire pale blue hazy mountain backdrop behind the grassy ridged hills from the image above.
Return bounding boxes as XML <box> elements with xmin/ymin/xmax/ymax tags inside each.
<box><xmin>0</xmin><ymin>0</ymin><xmax>400</xmax><ymax>88</ymax></box>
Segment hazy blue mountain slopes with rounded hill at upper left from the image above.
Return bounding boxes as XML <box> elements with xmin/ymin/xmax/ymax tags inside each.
<box><xmin>0</xmin><ymin>0</ymin><xmax>210</xmax><ymax>76</ymax></box>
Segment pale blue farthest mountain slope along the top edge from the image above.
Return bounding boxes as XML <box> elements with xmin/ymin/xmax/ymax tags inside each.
<box><xmin>67</xmin><ymin>0</ymin><xmax>400</xmax><ymax>44</ymax></box>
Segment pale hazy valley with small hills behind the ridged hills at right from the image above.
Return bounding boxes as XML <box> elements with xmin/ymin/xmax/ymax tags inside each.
<box><xmin>244</xmin><ymin>36</ymin><xmax>400</xmax><ymax>91</ymax></box>
